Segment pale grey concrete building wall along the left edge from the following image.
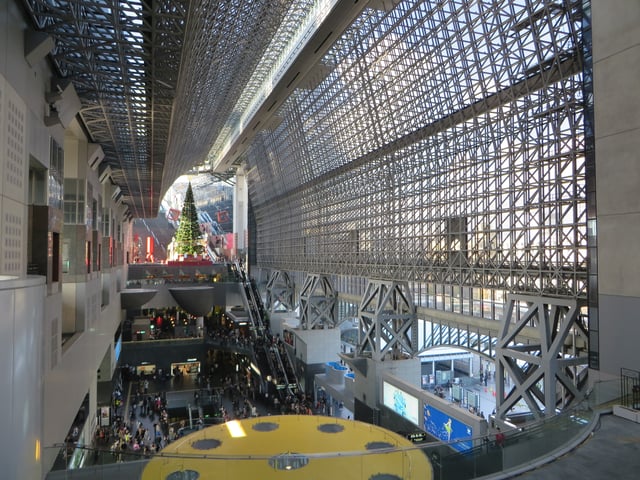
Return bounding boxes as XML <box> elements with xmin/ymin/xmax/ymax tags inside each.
<box><xmin>0</xmin><ymin>1</ymin><xmax>131</xmax><ymax>479</ymax></box>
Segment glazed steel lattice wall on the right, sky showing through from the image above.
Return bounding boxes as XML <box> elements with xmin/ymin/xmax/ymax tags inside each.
<box><xmin>246</xmin><ymin>0</ymin><xmax>587</xmax><ymax>322</ymax></box>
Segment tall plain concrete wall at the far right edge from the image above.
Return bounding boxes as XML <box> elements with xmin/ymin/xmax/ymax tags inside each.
<box><xmin>591</xmin><ymin>0</ymin><xmax>640</xmax><ymax>375</ymax></box>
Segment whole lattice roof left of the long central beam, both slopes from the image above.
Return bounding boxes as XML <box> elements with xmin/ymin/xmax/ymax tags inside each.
<box><xmin>23</xmin><ymin>0</ymin><xmax>312</xmax><ymax>217</ymax></box>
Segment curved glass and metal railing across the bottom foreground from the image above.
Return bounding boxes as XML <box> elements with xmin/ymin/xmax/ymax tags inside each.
<box><xmin>45</xmin><ymin>379</ymin><xmax>632</xmax><ymax>480</ymax></box>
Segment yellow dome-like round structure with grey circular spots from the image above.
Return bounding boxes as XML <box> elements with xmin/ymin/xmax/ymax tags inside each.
<box><xmin>142</xmin><ymin>415</ymin><xmax>432</xmax><ymax>480</ymax></box>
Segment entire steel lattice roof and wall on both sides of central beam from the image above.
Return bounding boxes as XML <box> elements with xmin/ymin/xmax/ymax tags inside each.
<box><xmin>18</xmin><ymin>0</ymin><xmax>595</xmax><ymax>318</ymax></box>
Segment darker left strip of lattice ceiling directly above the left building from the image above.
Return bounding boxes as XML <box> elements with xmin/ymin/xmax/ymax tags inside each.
<box><xmin>24</xmin><ymin>0</ymin><xmax>189</xmax><ymax>216</ymax></box>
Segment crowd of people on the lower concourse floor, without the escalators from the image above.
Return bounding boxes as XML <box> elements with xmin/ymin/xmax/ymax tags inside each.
<box><xmin>90</xmin><ymin>329</ymin><xmax>325</xmax><ymax>462</ymax></box>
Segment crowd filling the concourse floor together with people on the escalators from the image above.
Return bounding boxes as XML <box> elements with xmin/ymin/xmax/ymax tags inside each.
<box><xmin>85</xmin><ymin>262</ymin><xmax>344</xmax><ymax>461</ymax></box>
